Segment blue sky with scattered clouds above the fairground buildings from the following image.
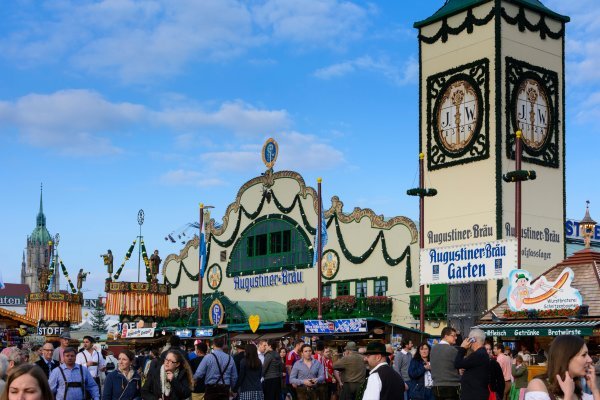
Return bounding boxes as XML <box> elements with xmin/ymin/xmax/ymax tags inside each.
<box><xmin>0</xmin><ymin>0</ymin><xmax>600</xmax><ymax>297</ymax></box>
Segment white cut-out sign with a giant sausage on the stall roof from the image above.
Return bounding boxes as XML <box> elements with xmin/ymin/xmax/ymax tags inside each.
<box><xmin>506</xmin><ymin>267</ymin><xmax>583</xmax><ymax>311</ymax></box>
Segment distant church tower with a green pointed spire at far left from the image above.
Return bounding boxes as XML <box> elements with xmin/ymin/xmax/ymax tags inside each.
<box><xmin>21</xmin><ymin>189</ymin><xmax>58</xmax><ymax>292</ymax></box>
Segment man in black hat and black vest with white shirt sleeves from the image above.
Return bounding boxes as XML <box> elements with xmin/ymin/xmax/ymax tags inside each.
<box><xmin>362</xmin><ymin>342</ymin><xmax>404</xmax><ymax>400</ymax></box>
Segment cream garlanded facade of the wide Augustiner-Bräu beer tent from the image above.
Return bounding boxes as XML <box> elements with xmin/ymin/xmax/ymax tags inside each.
<box><xmin>164</xmin><ymin>172</ymin><xmax>418</xmax><ymax>326</ymax></box>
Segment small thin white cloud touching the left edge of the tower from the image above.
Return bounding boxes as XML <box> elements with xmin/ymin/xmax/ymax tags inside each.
<box><xmin>313</xmin><ymin>56</ymin><xmax>419</xmax><ymax>86</ymax></box>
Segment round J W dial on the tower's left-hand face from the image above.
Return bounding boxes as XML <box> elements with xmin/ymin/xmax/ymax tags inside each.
<box><xmin>435</xmin><ymin>80</ymin><xmax>481</xmax><ymax>153</ymax></box>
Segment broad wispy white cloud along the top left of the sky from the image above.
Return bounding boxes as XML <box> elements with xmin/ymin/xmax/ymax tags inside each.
<box><xmin>0</xmin><ymin>0</ymin><xmax>371</xmax><ymax>83</ymax></box>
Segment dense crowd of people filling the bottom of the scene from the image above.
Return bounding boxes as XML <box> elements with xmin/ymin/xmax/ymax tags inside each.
<box><xmin>0</xmin><ymin>327</ymin><xmax>600</xmax><ymax>400</ymax></box>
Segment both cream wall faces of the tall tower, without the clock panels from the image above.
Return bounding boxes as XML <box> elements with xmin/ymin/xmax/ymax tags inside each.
<box><xmin>420</xmin><ymin>2</ymin><xmax>564</xmax><ymax>305</ymax></box>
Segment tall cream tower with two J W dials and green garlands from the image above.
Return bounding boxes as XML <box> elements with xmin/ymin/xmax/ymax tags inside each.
<box><xmin>414</xmin><ymin>0</ymin><xmax>569</xmax><ymax>330</ymax></box>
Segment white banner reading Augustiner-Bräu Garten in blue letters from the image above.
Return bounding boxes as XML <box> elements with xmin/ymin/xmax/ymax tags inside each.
<box><xmin>420</xmin><ymin>239</ymin><xmax>517</xmax><ymax>285</ymax></box>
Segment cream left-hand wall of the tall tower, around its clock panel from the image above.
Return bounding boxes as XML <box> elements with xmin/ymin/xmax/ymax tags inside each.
<box><xmin>421</xmin><ymin>2</ymin><xmax>496</xmax><ymax>248</ymax></box>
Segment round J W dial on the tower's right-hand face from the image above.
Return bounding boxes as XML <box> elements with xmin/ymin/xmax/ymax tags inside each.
<box><xmin>514</xmin><ymin>79</ymin><xmax>552</xmax><ymax>150</ymax></box>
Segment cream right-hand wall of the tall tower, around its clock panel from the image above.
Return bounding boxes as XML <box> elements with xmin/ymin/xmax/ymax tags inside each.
<box><xmin>502</xmin><ymin>3</ymin><xmax>565</xmax><ymax>276</ymax></box>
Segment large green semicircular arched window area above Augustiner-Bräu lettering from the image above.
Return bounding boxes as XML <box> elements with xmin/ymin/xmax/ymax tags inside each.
<box><xmin>227</xmin><ymin>214</ymin><xmax>313</xmax><ymax>276</ymax></box>
